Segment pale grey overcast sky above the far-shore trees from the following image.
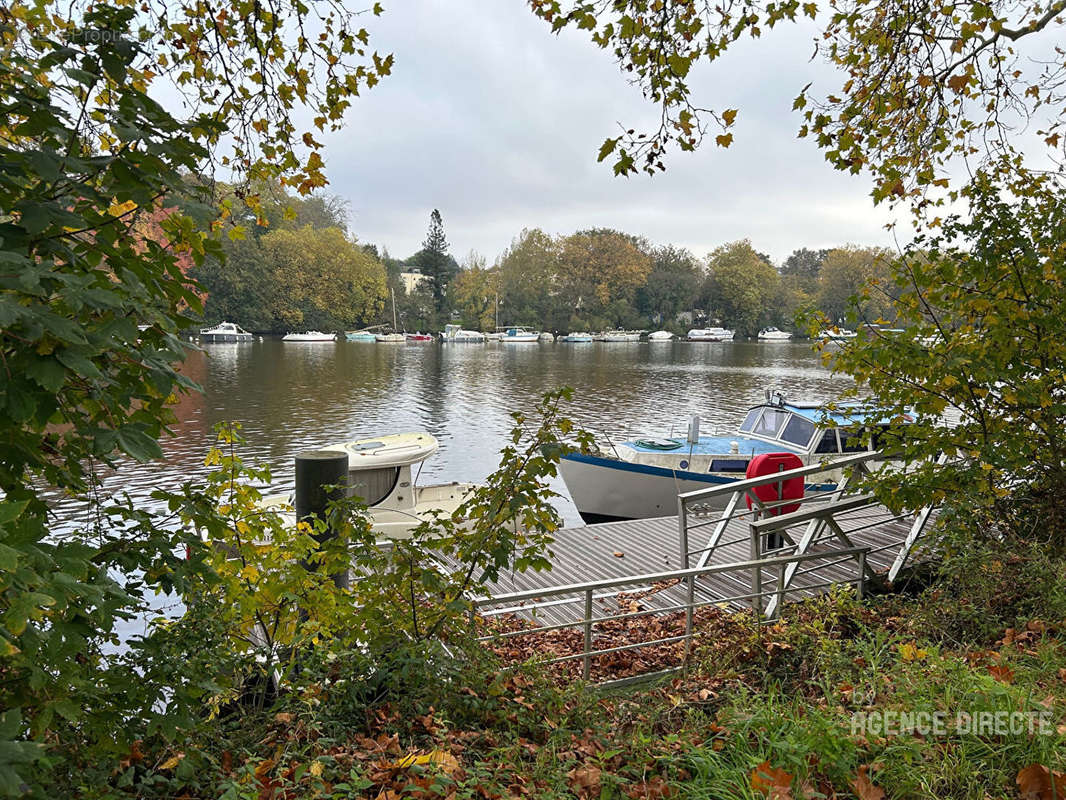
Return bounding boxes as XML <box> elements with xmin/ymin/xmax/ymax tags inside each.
<box><xmin>324</xmin><ymin>0</ymin><xmax>892</xmax><ymax>263</ymax></box>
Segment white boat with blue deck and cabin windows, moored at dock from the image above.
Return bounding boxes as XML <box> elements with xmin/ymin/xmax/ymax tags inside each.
<box><xmin>559</xmin><ymin>391</ymin><xmax>899</xmax><ymax>523</ymax></box>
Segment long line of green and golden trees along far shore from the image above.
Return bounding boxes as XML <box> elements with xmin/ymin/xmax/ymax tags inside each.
<box><xmin>191</xmin><ymin>188</ymin><xmax>892</xmax><ymax>336</ymax></box>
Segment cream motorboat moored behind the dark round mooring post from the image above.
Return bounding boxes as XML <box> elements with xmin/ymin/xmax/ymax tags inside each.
<box><xmin>262</xmin><ymin>433</ymin><xmax>477</xmax><ymax>539</ymax></box>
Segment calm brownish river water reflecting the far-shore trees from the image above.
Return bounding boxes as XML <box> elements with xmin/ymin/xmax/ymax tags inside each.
<box><xmin>63</xmin><ymin>339</ymin><xmax>847</xmax><ymax>525</ymax></box>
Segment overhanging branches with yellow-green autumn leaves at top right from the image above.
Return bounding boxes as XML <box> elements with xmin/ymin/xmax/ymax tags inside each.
<box><xmin>531</xmin><ymin>0</ymin><xmax>1066</xmax><ymax>211</ymax></box>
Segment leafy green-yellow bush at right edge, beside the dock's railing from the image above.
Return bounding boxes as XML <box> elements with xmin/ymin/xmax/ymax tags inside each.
<box><xmin>824</xmin><ymin>174</ymin><xmax>1066</xmax><ymax>539</ymax></box>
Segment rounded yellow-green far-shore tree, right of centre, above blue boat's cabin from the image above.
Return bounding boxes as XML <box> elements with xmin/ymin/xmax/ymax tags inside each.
<box><xmin>705</xmin><ymin>239</ymin><xmax>780</xmax><ymax>336</ymax></box>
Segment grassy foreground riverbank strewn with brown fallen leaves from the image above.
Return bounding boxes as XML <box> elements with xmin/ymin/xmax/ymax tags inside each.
<box><xmin>73</xmin><ymin>526</ymin><xmax>1066</xmax><ymax>800</ymax></box>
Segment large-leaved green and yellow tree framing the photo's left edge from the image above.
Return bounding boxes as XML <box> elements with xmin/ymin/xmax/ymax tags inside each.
<box><xmin>0</xmin><ymin>0</ymin><xmax>391</xmax><ymax>797</ymax></box>
